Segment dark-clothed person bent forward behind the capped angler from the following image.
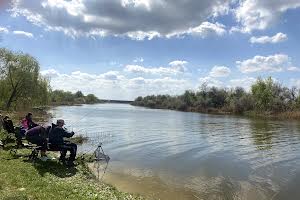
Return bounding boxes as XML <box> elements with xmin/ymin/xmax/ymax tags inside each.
<box><xmin>26</xmin><ymin>126</ymin><xmax>47</xmax><ymax>161</ymax></box>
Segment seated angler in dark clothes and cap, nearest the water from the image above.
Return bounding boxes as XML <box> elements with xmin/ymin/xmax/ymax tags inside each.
<box><xmin>49</xmin><ymin>119</ymin><xmax>77</xmax><ymax>166</ymax></box>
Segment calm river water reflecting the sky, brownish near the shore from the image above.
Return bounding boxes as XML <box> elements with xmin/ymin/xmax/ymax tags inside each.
<box><xmin>52</xmin><ymin>104</ymin><xmax>300</xmax><ymax>200</ymax></box>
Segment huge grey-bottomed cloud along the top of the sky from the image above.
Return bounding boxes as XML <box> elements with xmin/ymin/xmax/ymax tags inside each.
<box><xmin>10</xmin><ymin>0</ymin><xmax>232</xmax><ymax>40</ymax></box>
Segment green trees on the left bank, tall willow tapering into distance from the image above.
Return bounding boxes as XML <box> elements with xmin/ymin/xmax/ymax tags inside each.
<box><xmin>0</xmin><ymin>48</ymin><xmax>100</xmax><ymax>110</ymax></box>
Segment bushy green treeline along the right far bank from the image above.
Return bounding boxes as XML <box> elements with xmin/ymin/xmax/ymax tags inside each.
<box><xmin>132</xmin><ymin>77</ymin><xmax>300</xmax><ymax>117</ymax></box>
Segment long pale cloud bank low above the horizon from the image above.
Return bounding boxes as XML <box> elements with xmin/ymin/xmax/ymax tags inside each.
<box><xmin>42</xmin><ymin>69</ymin><xmax>193</xmax><ymax>100</ymax></box>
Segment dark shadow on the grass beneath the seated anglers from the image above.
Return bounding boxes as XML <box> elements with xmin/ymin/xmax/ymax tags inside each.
<box><xmin>26</xmin><ymin>160</ymin><xmax>78</xmax><ymax>178</ymax></box>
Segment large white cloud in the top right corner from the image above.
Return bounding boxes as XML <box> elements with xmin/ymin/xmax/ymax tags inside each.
<box><xmin>232</xmin><ymin>0</ymin><xmax>300</xmax><ymax>33</ymax></box>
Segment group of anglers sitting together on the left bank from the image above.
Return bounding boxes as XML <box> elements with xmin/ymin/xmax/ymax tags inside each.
<box><xmin>0</xmin><ymin>113</ymin><xmax>77</xmax><ymax>166</ymax></box>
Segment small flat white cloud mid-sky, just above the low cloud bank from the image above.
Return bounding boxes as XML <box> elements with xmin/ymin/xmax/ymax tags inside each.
<box><xmin>124</xmin><ymin>60</ymin><xmax>188</xmax><ymax>76</ymax></box>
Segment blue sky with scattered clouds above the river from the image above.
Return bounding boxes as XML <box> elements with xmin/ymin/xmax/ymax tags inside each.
<box><xmin>0</xmin><ymin>0</ymin><xmax>300</xmax><ymax>100</ymax></box>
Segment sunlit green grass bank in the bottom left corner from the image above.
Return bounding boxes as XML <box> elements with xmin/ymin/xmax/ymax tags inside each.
<box><xmin>0</xmin><ymin>149</ymin><xmax>142</xmax><ymax>200</ymax></box>
